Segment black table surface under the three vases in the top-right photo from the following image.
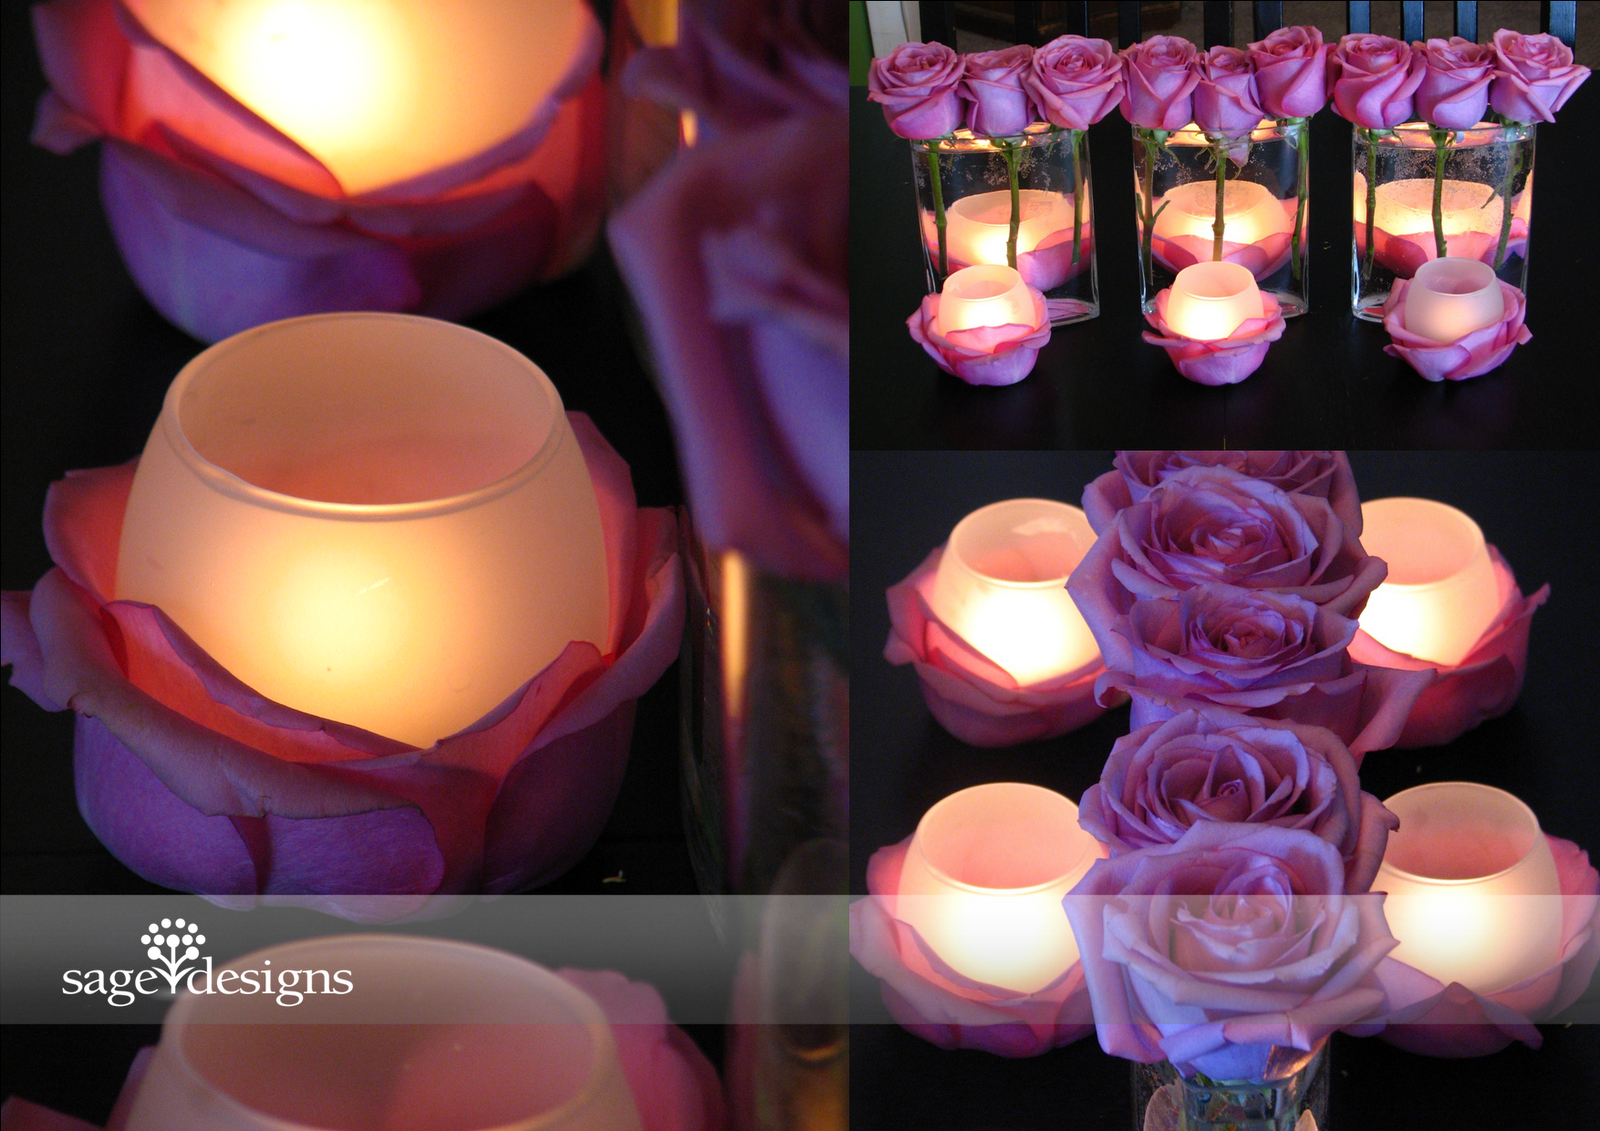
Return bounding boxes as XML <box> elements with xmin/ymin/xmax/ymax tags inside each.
<box><xmin>850</xmin><ymin>82</ymin><xmax>1600</xmax><ymax>450</ymax></box>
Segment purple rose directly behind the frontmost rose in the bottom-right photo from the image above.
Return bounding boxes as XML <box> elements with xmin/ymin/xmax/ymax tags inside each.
<box><xmin>1078</xmin><ymin>709</ymin><xmax>1397</xmax><ymax>894</ymax></box>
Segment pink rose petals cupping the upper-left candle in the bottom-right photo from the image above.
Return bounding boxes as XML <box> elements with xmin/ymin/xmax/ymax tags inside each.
<box><xmin>883</xmin><ymin>546</ymin><xmax>1106</xmax><ymax>745</ymax></box>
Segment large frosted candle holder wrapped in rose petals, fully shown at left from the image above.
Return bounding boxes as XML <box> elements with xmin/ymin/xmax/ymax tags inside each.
<box><xmin>0</xmin><ymin>321</ymin><xmax>683</xmax><ymax>918</ymax></box>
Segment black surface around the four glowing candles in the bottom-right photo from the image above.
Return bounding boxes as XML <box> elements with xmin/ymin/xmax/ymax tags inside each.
<box><xmin>850</xmin><ymin>451</ymin><xmax>1600</xmax><ymax>1131</ymax></box>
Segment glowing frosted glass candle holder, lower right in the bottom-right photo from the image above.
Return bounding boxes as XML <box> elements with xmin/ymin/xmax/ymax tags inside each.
<box><xmin>1373</xmin><ymin>782</ymin><xmax>1562</xmax><ymax>993</ymax></box>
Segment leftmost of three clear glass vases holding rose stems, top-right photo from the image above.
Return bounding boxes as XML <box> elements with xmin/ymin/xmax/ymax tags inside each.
<box><xmin>910</xmin><ymin>122</ymin><xmax>1099</xmax><ymax>326</ymax></box>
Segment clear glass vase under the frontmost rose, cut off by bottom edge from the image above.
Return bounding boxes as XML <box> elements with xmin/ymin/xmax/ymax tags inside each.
<box><xmin>1133</xmin><ymin>1040</ymin><xmax>1330</xmax><ymax>1131</ymax></box>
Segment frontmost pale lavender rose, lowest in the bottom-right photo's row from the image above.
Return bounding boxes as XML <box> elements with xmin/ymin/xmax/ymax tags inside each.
<box><xmin>1064</xmin><ymin>821</ymin><xmax>1397</xmax><ymax>1080</ymax></box>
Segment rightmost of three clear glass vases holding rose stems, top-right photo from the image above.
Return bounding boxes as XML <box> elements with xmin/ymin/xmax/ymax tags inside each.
<box><xmin>1350</xmin><ymin>122</ymin><xmax>1534</xmax><ymax>322</ymax></box>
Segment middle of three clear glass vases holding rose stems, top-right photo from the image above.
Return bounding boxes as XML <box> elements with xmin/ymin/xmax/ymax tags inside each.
<box><xmin>1133</xmin><ymin>118</ymin><xmax>1310</xmax><ymax>318</ymax></box>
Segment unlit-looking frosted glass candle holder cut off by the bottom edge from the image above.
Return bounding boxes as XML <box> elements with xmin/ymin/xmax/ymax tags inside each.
<box><xmin>126</xmin><ymin>934</ymin><xmax>640</xmax><ymax>1131</ymax></box>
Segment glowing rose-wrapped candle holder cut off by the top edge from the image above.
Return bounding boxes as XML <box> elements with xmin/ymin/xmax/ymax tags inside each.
<box><xmin>34</xmin><ymin>0</ymin><xmax>605</xmax><ymax>341</ymax></box>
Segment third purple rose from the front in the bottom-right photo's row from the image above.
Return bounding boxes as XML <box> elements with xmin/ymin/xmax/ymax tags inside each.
<box><xmin>1091</xmin><ymin>584</ymin><xmax>1434</xmax><ymax>765</ymax></box>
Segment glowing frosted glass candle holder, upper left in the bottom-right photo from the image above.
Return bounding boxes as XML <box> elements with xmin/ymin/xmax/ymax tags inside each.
<box><xmin>930</xmin><ymin>499</ymin><xmax>1099</xmax><ymax>685</ymax></box>
